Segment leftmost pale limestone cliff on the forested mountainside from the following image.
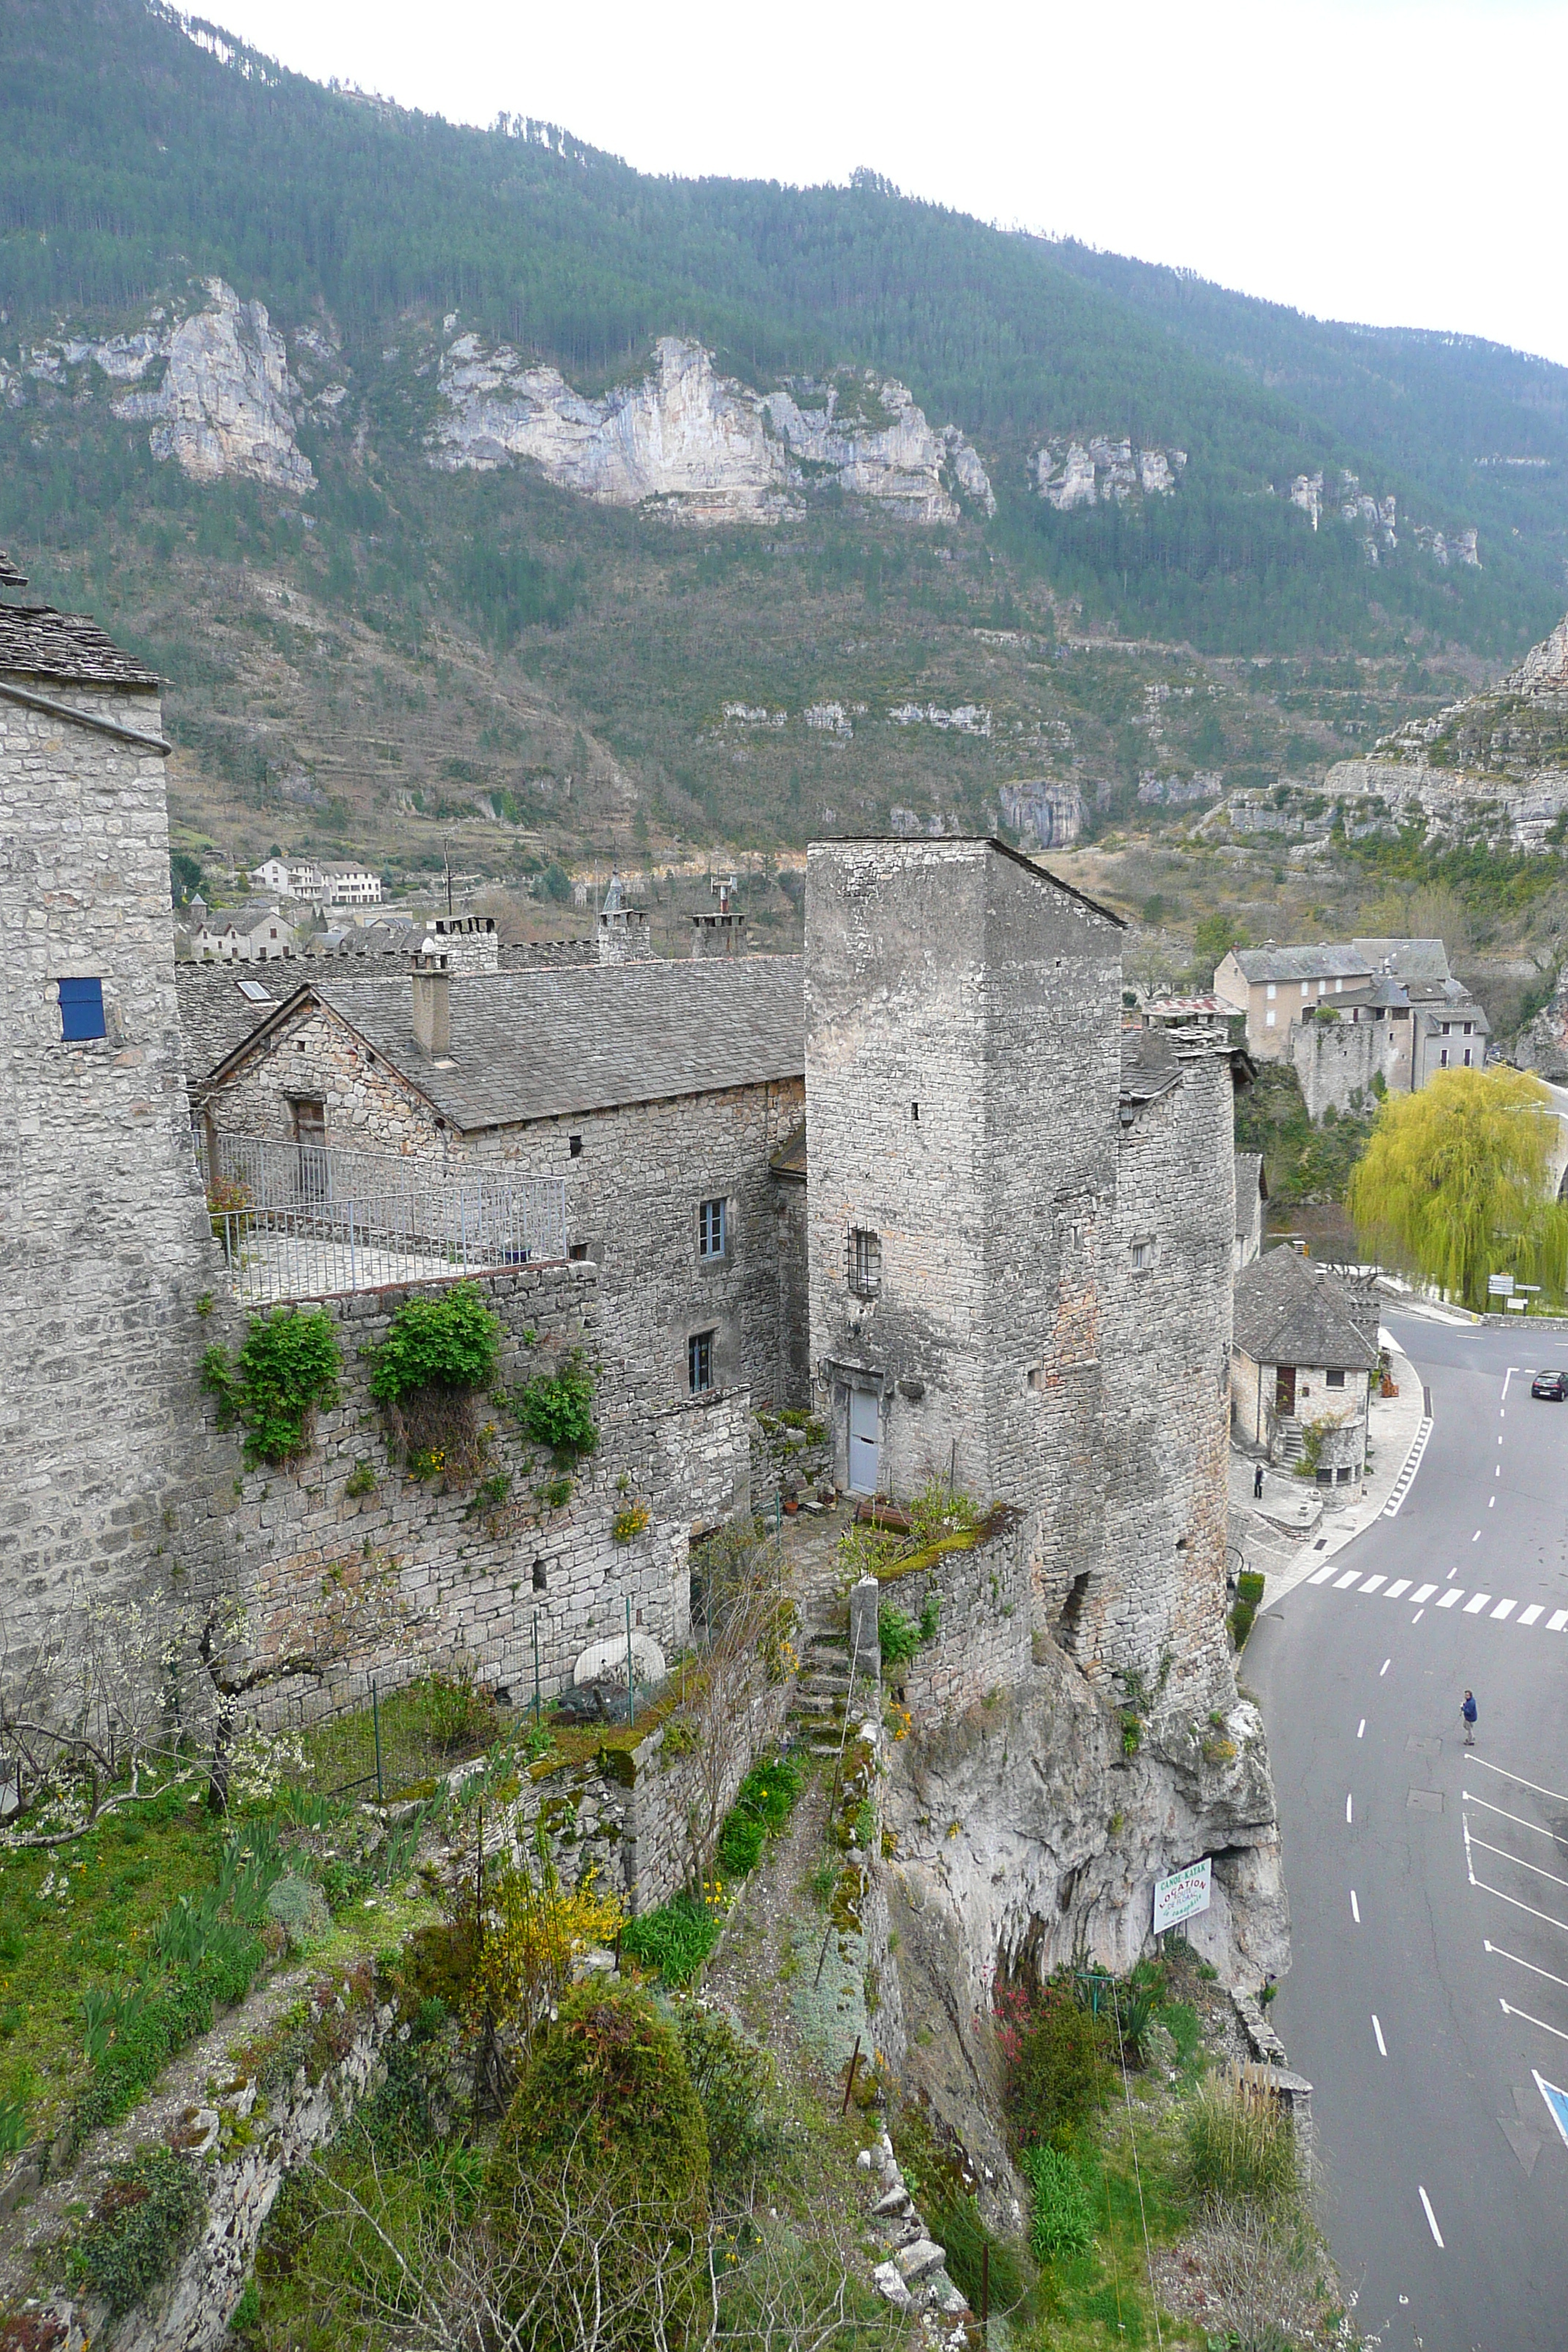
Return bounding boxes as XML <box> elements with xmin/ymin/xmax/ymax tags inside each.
<box><xmin>113</xmin><ymin>277</ymin><xmax>315</xmax><ymax>497</ymax></box>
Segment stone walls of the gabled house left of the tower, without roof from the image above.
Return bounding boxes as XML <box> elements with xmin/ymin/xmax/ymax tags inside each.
<box><xmin>205</xmin><ymin>981</ymin><xmax>804</xmax><ymax>1404</ymax></box>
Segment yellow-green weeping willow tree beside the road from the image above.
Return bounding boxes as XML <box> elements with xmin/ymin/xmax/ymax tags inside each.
<box><xmin>1349</xmin><ymin>1070</ymin><xmax>1568</xmax><ymax>1308</ymax></box>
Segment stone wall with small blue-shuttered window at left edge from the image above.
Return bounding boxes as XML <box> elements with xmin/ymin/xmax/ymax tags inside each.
<box><xmin>0</xmin><ymin>685</ymin><xmax>235</xmax><ymax>1665</ymax></box>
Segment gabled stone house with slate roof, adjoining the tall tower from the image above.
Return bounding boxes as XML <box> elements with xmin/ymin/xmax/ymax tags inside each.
<box><xmin>193</xmin><ymin>957</ymin><xmax>804</xmax><ymax>1404</ymax></box>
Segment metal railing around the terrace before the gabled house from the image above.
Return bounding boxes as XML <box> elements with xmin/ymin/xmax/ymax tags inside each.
<box><xmin>195</xmin><ymin>1136</ymin><xmax>567</xmax><ymax>1305</ymax></box>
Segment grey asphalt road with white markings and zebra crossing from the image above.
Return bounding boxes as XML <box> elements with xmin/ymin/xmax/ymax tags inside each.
<box><xmin>1243</xmin><ymin>1317</ymin><xmax>1568</xmax><ymax>2352</ymax></box>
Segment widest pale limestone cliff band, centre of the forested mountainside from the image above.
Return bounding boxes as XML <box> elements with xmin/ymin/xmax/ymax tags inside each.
<box><xmin>430</xmin><ymin>334</ymin><xmax>997</xmax><ymax>524</ymax></box>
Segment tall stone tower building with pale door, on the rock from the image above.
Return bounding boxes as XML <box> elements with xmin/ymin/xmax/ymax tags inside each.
<box><xmin>807</xmin><ymin>840</ymin><xmax>1235</xmax><ymax>1703</ymax></box>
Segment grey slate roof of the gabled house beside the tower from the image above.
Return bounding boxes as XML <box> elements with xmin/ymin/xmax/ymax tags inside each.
<box><xmin>281</xmin><ymin>955</ymin><xmax>807</xmax><ymax>1131</ymax></box>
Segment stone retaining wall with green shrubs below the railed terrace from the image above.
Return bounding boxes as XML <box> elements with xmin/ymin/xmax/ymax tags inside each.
<box><xmin>223</xmin><ymin>1265</ymin><xmax>750</xmax><ymax>1724</ymax></box>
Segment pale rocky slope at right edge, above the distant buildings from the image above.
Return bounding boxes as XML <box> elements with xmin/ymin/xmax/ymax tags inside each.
<box><xmin>1324</xmin><ymin>619</ymin><xmax>1568</xmax><ymax>849</ymax></box>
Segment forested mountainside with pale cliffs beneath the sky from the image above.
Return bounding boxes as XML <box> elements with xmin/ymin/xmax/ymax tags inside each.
<box><xmin>0</xmin><ymin>0</ymin><xmax>1568</xmax><ymax>889</ymax></box>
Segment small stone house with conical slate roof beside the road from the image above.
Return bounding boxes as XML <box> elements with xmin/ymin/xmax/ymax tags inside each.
<box><xmin>1229</xmin><ymin>1249</ymin><xmax>1378</xmax><ymax>1487</ymax></box>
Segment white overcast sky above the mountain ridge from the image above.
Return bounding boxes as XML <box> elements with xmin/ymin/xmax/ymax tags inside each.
<box><xmin>208</xmin><ymin>0</ymin><xmax>1568</xmax><ymax>362</ymax></box>
